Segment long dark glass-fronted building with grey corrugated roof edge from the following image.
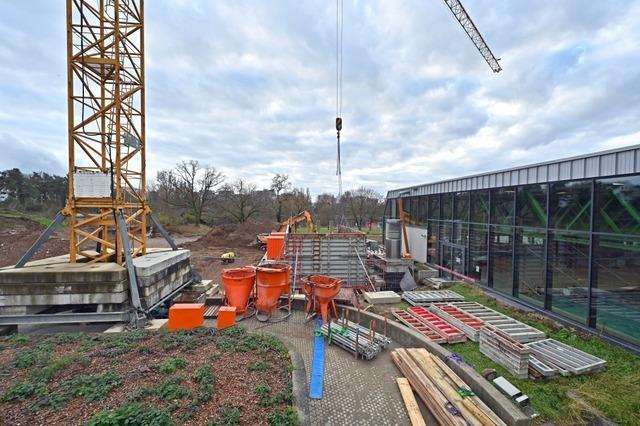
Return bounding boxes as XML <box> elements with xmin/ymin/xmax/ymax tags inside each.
<box><xmin>385</xmin><ymin>147</ymin><xmax>640</xmax><ymax>347</ymax></box>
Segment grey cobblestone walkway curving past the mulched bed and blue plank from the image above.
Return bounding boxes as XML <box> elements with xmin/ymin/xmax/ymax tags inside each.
<box><xmin>232</xmin><ymin>311</ymin><xmax>410</xmax><ymax>425</ymax></box>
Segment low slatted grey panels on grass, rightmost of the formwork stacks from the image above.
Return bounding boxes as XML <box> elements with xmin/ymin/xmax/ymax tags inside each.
<box><xmin>526</xmin><ymin>339</ymin><xmax>607</xmax><ymax>376</ymax></box>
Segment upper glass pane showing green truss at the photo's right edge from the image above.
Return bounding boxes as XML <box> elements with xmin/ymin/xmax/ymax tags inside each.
<box><xmin>594</xmin><ymin>176</ymin><xmax>640</xmax><ymax>235</ymax></box>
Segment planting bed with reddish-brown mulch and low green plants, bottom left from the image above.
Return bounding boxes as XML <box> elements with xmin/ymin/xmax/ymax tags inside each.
<box><xmin>0</xmin><ymin>327</ymin><xmax>295</xmax><ymax>425</ymax></box>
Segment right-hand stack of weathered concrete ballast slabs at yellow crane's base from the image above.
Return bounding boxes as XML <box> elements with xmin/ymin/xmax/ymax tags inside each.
<box><xmin>133</xmin><ymin>250</ymin><xmax>191</xmax><ymax>308</ymax></box>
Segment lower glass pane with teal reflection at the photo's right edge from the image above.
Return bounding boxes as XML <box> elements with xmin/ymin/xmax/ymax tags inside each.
<box><xmin>591</xmin><ymin>235</ymin><xmax>640</xmax><ymax>345</ymax></box>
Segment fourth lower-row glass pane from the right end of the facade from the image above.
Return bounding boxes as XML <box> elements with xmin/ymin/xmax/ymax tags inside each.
<box><xmin>490</xmin><ymin>226</ymin><xmax>513</xmax><ymax>294</ymax></box>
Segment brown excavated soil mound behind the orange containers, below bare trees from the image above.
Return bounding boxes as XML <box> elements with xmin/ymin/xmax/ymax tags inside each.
<box><xmin>184</xmin><ymin>222</ymin><xmax>277</xmax><ymax>250</ymax></box>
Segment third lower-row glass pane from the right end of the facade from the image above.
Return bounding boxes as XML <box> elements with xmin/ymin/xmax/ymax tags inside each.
<box><xmin>516</xmin><ymin>229</ymin><xmax>545</xmax><ymax>306</ymax></box>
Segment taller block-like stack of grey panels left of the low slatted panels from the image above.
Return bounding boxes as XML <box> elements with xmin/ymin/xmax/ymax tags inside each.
<box><xmin>480</xmin><ymin>325</ymin><xmax>531</xmax><ymax>379</ymax></box>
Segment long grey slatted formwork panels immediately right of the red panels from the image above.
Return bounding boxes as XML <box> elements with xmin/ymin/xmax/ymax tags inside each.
<box><xmin>451</xmin><ymin>302</ymin><xmax>546</xmax><ymax>343</ymax></box>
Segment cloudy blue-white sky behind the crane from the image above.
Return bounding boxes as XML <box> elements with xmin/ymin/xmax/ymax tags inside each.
<box><xmin>0</xmin><ymin>0</ymin><xmax>640</xmax><ymax>195</ymax></box>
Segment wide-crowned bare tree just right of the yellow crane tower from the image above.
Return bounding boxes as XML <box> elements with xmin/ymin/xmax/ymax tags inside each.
<box><xmin>156</xmin><ymin>160</ymin><xmax>224</xmax><ymax>226</ymax></box>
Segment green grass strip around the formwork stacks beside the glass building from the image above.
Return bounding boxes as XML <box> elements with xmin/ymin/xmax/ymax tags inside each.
<box><xmin>447</xmin><ymin>283</ymin><xmax>640</xmax><ymax>425</ymax></box>
